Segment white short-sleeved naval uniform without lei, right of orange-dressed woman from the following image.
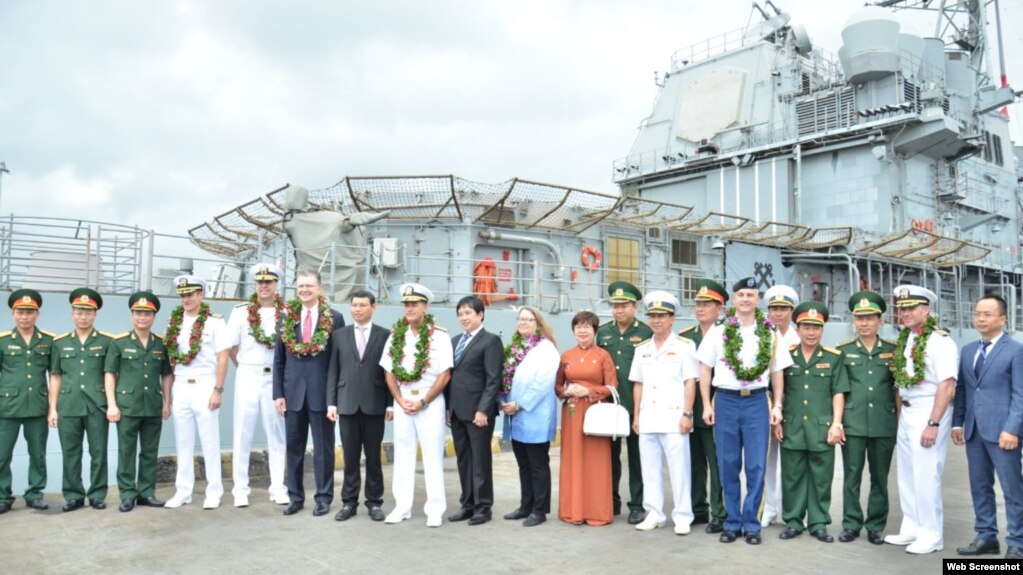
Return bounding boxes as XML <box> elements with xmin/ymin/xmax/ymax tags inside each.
<box><xmin>629</xmin><ymin>335</ymin><xmax>700</xmax><ymax>527</ymax></box>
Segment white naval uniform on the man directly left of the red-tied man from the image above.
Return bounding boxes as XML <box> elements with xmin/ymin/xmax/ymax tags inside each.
<box><xmin>227</xmin><ymin>303</ymin><xmax>288</xmax><ymax>502</ymax></box>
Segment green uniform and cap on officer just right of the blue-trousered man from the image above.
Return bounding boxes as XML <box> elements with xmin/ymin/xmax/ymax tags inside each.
<box><xmin>782</xmin><ymin>302</ymin><xmax>849</xmax><ymax>533</ymax></box>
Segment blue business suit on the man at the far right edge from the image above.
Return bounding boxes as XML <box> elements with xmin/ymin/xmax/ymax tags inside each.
<box><xmin>952</xmin><ymin>334</ymin><xmax>1023</xmax><ymax>547</ymax></box>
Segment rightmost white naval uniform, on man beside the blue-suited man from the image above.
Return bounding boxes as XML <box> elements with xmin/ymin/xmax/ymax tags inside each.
<box><xmin>896</xmin><ymin>331</ymin><xmax>959</xmax><ymax>547</ymax></box>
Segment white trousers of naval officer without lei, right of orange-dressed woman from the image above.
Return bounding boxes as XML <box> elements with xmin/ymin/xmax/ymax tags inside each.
<box><xmin>639</xmin><ymin>433</ymin><xmax>693</xmax><ymax>525</ymax></box>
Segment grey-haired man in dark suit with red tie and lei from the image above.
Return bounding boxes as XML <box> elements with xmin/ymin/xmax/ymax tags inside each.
<box><xmin>273</xmin><ymin>270</ymin><xmax>345</xmax><ymax>516</ymax></box>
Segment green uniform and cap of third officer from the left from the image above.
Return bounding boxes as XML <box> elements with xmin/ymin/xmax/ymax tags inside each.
<box><xmin>103</xmin><ymin>292</ymin><xmax>174</xmax><ymax>501</ymax></box>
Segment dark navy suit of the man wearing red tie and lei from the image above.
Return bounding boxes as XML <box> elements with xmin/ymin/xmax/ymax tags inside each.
<box><xmin>273</xmin><ymin>309</ymin><xmax>345</xmax><ymax>504</ymax></box>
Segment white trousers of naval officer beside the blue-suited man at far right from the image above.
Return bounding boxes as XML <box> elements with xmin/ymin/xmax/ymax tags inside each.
<box><xmin>896</xmin><ymin>397</ymin><xmax>952</xmax><ymax>545</ymax></box>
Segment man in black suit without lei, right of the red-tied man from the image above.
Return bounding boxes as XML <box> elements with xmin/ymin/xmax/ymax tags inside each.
<box><xmin>326</xmin><ymin>291</ymin><xmax>394</xmax><ymax>521</ymax></box>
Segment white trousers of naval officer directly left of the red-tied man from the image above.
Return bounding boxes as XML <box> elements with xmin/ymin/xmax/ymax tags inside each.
<box><xmin>231</xmin><ymin>365</ymin><xmax>287</xmax><ymax>498</ymax></box>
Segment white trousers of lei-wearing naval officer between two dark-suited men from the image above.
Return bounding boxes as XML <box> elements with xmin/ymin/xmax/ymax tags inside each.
<box><xmin>391</xmin><ymin>386</ymin><xmax>447</xmax><ymax>518</ymax></box>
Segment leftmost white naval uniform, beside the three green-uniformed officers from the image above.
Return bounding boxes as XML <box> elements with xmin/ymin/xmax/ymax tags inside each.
<box><xmin>171</xmin><ymin>312</ymin><xmax>231</xmax><ymax>501</ymax></box>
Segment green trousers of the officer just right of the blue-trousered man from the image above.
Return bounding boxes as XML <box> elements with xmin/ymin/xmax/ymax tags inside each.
<box><xmin>782</xmin><ymin>444</ymin><xmax>835</xmax><ymax>533</ymax></box>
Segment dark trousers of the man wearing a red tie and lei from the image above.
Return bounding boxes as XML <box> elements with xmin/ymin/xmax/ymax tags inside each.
<box><xmin>284</xmin><ymin>409</ymin><xmax>333</xmax><ymax>503</ymax></box>
